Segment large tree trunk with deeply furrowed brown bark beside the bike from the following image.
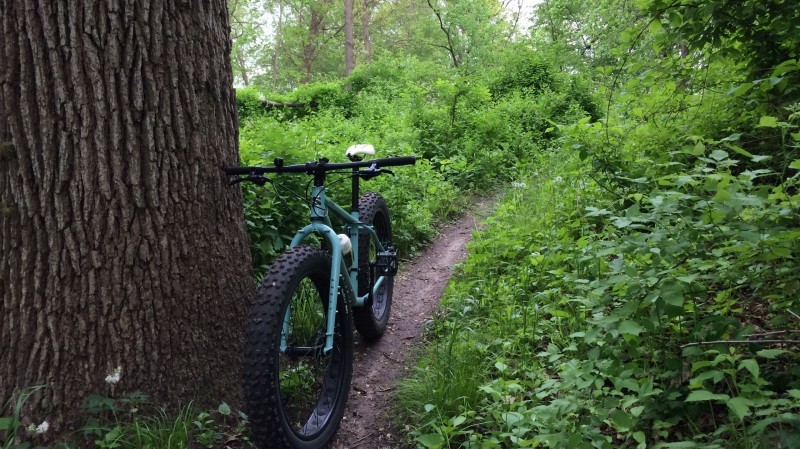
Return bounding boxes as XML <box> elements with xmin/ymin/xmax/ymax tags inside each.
<box><xmin>0</xmin><ymin>0</ymin><xmax>253</xmax><ymax>433</ymax></box>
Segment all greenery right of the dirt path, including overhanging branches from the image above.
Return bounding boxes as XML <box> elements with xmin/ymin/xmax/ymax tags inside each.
<box><xmin>398</xmin><ymin>2</ymin><xmax>800</xmax><ymax>448</ymax></box>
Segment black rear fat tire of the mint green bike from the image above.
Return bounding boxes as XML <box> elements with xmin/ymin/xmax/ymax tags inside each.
<box><xmin>353</xmin><ymin>192</ymin><xmax>394</xmax><ymax>340</ymax></box>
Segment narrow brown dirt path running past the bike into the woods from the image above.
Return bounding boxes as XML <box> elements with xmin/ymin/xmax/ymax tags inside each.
<box><xmin>330</xmin><ymin>201</ymin><xmax>489</xmax><ymax>449</ymax></box>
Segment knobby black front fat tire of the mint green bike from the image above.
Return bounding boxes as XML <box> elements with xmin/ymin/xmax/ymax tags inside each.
<box><xmin>243</xmin><ymin>246</ymin><xmax>353</xmax><ymax>449</ymax></box>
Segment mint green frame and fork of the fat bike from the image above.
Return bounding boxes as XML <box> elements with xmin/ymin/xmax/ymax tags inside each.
<box><xmin>281</xmin><ymin>186</ymin><xmax>386</xmax><ymax>354</ymax></box>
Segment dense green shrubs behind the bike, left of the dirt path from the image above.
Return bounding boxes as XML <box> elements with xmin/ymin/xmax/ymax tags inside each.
<box><xmin>233</xmin><ymin>52</ymin><xmax>591</xmax><ymax>272</ymax></box>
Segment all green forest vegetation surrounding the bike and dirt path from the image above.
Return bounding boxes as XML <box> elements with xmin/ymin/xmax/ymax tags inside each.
<box><xmin>2</xmin><ymin>0</ymin><xmax>800</xmax><ymax>448</ymax></box>
